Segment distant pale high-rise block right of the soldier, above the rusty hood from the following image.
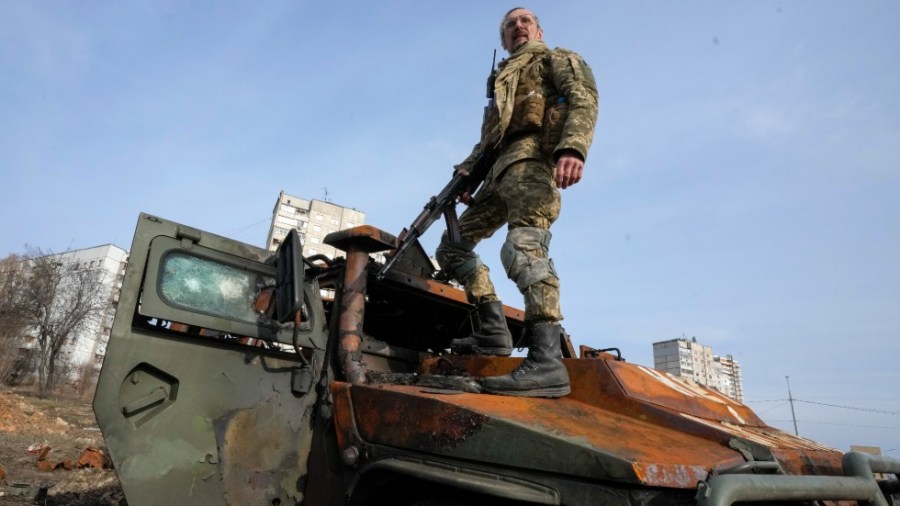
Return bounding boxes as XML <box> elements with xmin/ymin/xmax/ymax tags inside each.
<box><xmin>653</xmin><ymin>337</ymin><xmax>744</xmax><ymax>402</ymax></box>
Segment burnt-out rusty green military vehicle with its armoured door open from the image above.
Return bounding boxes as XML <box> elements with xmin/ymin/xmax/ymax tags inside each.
<box><xmin>94</xmin><ymin>214</ymin><xmax>900</xmax><ymax>506</ymax></box>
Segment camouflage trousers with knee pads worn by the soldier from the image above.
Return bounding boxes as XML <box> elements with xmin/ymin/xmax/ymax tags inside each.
<box><xmin>435</xmin><ymin>160</ymin><xmax>562</xmax><ymax>321</ymax></box>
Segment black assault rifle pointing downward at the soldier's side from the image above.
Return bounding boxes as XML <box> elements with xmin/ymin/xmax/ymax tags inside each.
<box><xmin>375</xmin><ymin>153</ymin><xmax>494</xmax><ymax>280</ymax></box>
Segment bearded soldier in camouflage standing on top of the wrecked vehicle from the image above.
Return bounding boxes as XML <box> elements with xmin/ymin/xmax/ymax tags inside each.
<box><xmin>435</xmin><ymin>7</ymin><xmax>597</xmax><ymax>397</ymax></box>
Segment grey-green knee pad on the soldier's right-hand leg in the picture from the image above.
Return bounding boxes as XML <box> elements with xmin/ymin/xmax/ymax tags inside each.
<box><xmin>500</xmin><ymin>227</ymin><xmax>557</xmax><ymax>293</ymax></box>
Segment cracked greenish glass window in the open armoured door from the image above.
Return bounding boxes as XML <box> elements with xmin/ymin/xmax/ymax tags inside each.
<box><xmin>159</xmin><ymin>252</ymin><xmax>275</xmax><ymax>324</ymax></box>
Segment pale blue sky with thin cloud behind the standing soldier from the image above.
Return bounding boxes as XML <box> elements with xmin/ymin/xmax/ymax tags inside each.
<box><xmin>0</xmin><ymin>0</ymin><xmax>900</xmax><ymax>457</ymax></box>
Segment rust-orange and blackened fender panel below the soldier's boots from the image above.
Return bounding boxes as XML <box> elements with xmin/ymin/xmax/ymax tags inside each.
<box><xmin>342</xmin><ymin>385</ymin><xmax>740</xmax><ymax>488</ymax></box>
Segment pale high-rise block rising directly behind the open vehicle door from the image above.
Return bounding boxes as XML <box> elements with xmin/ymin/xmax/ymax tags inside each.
<box><xmin>266</xmin><ymin>191</ymin><xmax>366</xmax><ymax>258</ymax></box>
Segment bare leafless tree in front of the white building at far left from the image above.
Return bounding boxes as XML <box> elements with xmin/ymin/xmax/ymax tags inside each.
<box><xmin>1</xmin><ymin>248</ymin><xmax>108</xmax><ymax>397</ymax></box>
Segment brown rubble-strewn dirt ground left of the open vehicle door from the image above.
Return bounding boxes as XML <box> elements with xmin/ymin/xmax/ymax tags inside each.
<box><xmin>0</xmin><ymin>387</ymin><xmax>126</xmax><ymax>506</ymax></box>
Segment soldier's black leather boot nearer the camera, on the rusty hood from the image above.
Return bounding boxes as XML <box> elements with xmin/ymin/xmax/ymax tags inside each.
<box><xmin>481</xmin><ymin>322</ymin><xmax>570</xmax><ymax>397</ymax></box>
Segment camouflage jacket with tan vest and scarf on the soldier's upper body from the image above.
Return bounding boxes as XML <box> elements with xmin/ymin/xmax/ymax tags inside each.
<box><xmin>456</xmin><ymin>41</ymin><xmax>597</xmax><ymax>184</ymax></box>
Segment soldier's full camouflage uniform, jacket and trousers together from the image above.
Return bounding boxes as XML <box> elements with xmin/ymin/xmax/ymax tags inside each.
<box><xmin>436</xmin><ymin>40</ymin><xmax>597</xmax><ymax>321</ymax></box>
